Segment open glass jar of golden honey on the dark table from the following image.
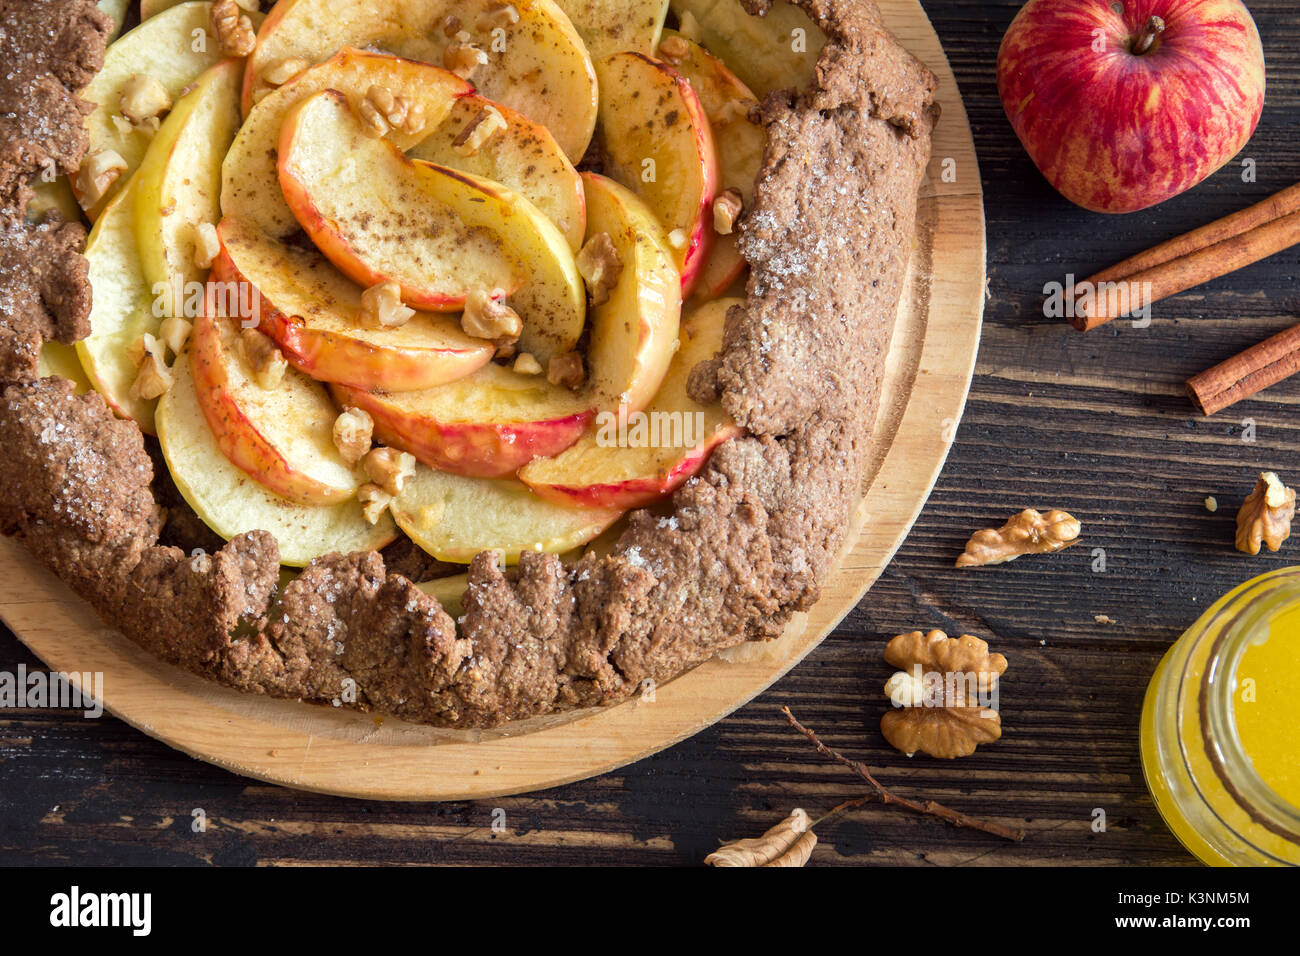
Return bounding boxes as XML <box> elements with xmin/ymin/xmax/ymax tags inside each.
<box><xmin>1141</xmin><ymin>567</ymin><xmax>1300</xmax><ymax>866</ymax></box>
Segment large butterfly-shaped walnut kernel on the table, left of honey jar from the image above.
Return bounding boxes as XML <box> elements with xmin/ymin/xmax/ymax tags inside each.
<box><xmin>880</xmin><ymin>631</ymin><xmax>1006</xmax><ymax>760</ymax></box>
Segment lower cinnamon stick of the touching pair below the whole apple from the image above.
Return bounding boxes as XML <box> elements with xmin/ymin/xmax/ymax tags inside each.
<box><xmin>1070</xmin><ymin>208</ymin><xmax>1300</xmax><ymax>332</ymax></box>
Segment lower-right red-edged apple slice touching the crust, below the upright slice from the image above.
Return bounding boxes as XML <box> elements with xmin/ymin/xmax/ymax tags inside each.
<box><xmin>519</xmin><ymin>299</ymin><xmax>741</xmax><ymax>510</ymax></box>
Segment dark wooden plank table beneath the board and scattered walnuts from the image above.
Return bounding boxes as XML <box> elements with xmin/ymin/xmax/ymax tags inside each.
<box><xmin>0</xmin><ymin>0</ymin><xmax>1300</xmax><ymax>865</ymax></box>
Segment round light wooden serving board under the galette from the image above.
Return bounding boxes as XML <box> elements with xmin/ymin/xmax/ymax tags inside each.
<box><xmin>0</xmin><ymin>0</ymin><xmax>984</xmax><ymax>800</ymax></box>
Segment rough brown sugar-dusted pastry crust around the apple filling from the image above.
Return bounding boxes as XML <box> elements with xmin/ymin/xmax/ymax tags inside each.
<box><xmin>0</xmin><ymin>0</ymin><xmax>939</xmax><ymax>727</ymax></box>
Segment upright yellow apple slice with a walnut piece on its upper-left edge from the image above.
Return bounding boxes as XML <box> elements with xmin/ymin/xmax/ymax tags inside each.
<box><xmin>582</xmin><ymin>173</ymin><xmax>681</xmax><ymax>411</ymax></box>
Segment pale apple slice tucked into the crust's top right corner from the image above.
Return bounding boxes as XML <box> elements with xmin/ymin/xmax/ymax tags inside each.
<box><xmin>671</xmin><ymin>0</ymin><xmax>826</xmax><ymax>96</ymax></box>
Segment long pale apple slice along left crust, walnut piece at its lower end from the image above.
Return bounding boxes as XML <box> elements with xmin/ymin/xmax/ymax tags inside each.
<box><xmin>77</xmin><ymin>178</ymin><xmax>161</xmax><ymax>434</ymax></box>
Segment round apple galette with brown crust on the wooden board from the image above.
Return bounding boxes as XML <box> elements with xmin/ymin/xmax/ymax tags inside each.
<box><xmin>0</xmin><ymin>0</ymin><xmax>937</xmax><ymax>726</ymax></box>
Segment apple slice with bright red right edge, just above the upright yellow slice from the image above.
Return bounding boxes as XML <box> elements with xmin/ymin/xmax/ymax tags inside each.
<box><xmin>597</xmin><ymin>53</ymin><xmax>718</xmax><ymax>294</ymax></box>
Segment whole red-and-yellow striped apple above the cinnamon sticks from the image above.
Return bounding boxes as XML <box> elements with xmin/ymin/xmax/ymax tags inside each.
<box><xmin>997</xmin><ymin>0</ymin><xmax>1264</xmax><ymax>212</ymax></box>
